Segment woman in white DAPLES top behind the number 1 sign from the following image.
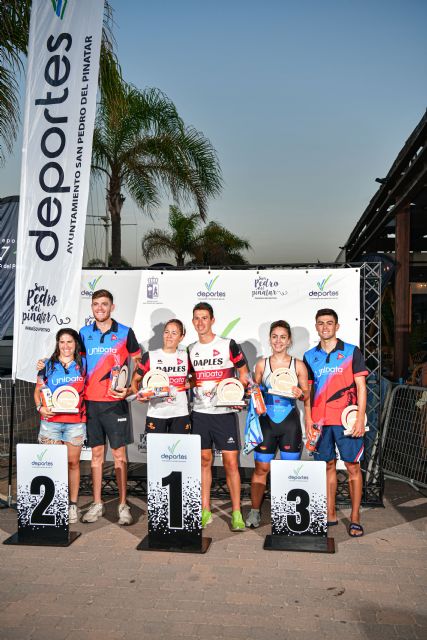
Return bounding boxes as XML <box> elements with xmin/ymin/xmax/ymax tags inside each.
<box><xmin>132</xmin><ymin>318</ymin><xmax>191</xmax><ymax>434</ymax></box>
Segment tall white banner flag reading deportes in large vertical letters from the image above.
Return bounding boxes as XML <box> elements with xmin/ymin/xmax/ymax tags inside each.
<box><xmin>12</xmin><ymin>0</ymin><xmax>104</xmax><ymax>381</ymax></box>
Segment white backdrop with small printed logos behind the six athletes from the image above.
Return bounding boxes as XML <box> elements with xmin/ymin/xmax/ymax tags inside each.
<box><xmin>76</xmin><ymin>268</ymin><xmax>360</xmax><ymax>466</ymax></box>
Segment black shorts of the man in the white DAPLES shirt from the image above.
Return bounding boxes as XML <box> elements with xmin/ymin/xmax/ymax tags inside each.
<box><xmin>191</xmin><ymin>411</ymin><xmax>239</xmax><ymax>451</ymax></box>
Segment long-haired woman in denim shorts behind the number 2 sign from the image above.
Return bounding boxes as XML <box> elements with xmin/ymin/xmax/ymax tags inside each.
<box><xmin>34</xmin><ymin>329</ymin><xmax>86</xmax><ymax>523</ymax></box>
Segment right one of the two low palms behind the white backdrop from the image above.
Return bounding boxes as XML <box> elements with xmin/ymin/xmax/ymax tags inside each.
<box><xmin>191</xmin><ymin>222</ymin><xmax>252</xmax><ymax>266</ymax></box>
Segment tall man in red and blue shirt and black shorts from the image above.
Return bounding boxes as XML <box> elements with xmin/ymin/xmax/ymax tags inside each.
<box><xmin>80</xmin><ymin>289</ymin><xmax>141</xmax><ymax>525</ymax></box>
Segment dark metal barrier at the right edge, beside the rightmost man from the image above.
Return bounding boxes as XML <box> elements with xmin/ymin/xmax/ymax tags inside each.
<box><xmin>382</xmin><ymin>385</ymin><xmax>427</xmax><ymax>487</ymax></box>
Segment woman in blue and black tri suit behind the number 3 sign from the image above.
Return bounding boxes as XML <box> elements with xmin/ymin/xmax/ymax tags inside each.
<box><xmin>246</xmin><ymin>320</ymin><xmax>310</xmax><ymax>528</ymax></box>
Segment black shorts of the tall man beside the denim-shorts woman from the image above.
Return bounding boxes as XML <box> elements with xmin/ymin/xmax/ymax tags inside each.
<box><xmin>86</xmin><ymin>400</ymin><xmax>133</xmax><ymax>449</ymax></box>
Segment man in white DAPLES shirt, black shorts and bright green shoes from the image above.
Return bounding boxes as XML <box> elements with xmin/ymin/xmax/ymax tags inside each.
<box><xmin>188</xmin><ymin>302</ymin><xmax>249</xmax><ymax>531</ymax></box>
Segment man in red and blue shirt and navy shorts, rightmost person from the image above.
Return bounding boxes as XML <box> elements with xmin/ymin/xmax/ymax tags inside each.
<box><xmin>304</xmin><ymin>309</ymin><xmax>368</xmax><ymax>538</ymax></box>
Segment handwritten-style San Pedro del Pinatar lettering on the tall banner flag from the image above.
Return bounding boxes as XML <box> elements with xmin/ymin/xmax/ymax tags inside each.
<box><xmin>21</xmin><ymin>282</ymin><xmax>70</xmax><ymax>332</ymax></box>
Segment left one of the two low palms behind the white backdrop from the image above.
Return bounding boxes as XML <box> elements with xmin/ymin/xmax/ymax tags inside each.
<box><xmin>142</xmin><ymin>205</ymin><xmax>200</xmax><ymax>267</ymax></box>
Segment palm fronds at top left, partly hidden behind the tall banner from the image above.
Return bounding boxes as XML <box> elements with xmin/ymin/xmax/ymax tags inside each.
<box><xmin>0</xmin><ymin>0</ymin><xmax>120</xmax><ymax>166</ymax></box>
